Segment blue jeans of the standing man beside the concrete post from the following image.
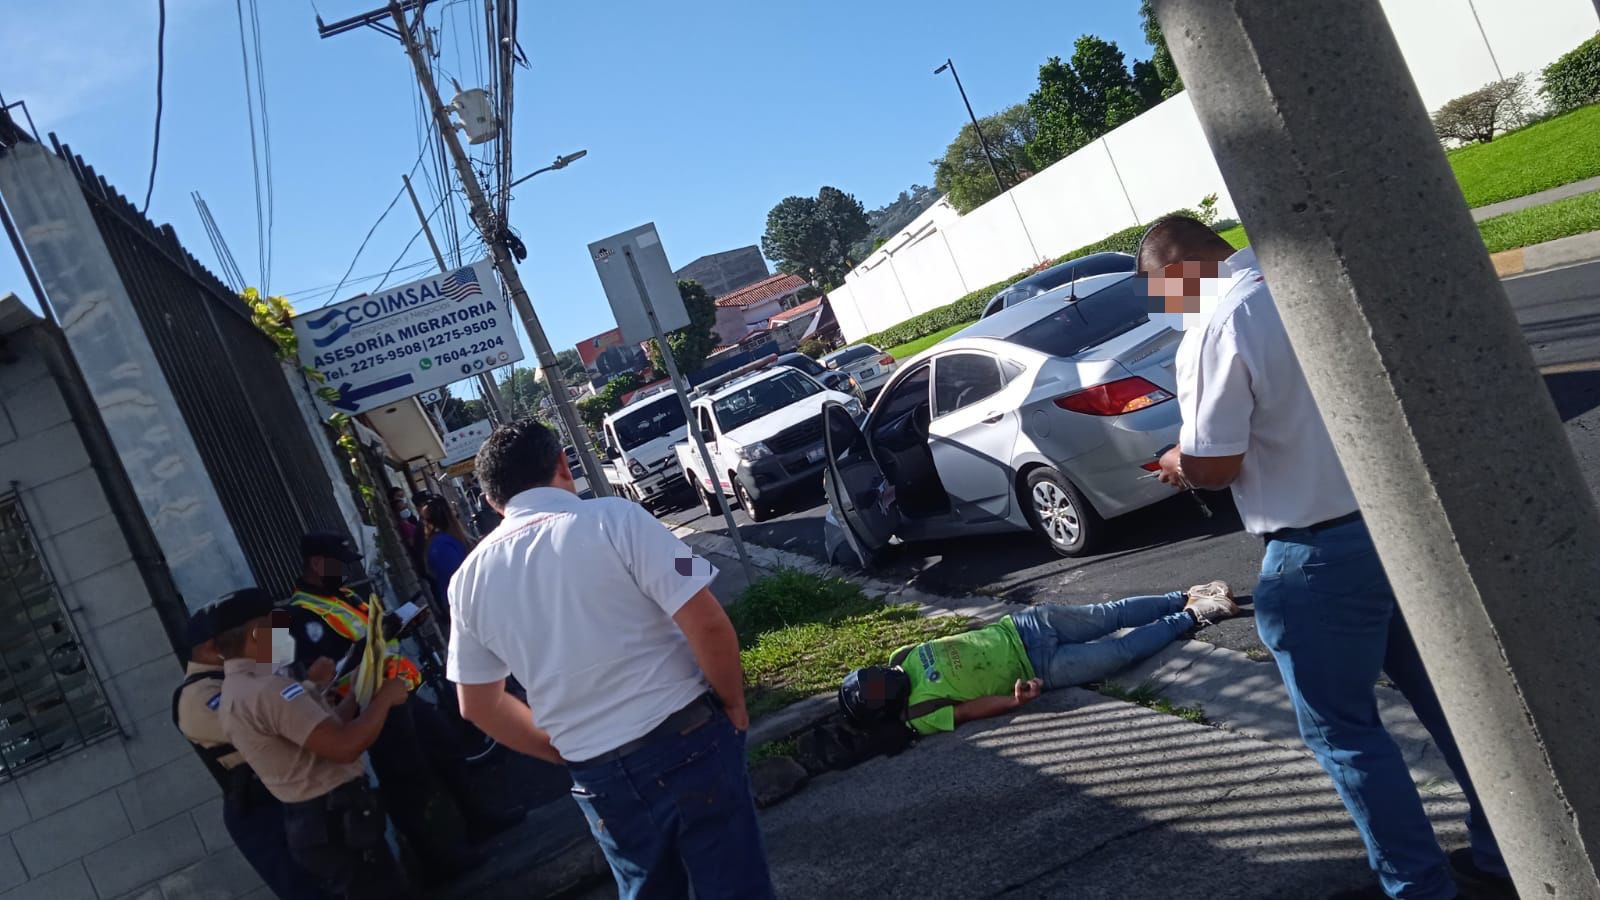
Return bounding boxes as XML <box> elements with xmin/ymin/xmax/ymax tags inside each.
<box><xmin>1256</xmin><ymin>520</ymin><xmax>1507</xmax><ymax>900</ymax></box>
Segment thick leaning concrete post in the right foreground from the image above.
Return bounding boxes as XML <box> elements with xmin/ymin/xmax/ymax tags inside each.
<box><xmin>1155</xmin><ymin>0</ymin><xmax>1600</xmax><ymax>897</ymax></box>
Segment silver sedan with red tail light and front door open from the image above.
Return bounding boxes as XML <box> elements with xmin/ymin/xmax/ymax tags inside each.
<box><xmin>822</xmin><ymin>274</ymin><xmax>1181</xmax><ymax>565</ymax></box>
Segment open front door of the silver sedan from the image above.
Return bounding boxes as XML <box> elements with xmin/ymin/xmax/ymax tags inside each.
<box><xmin>822</xmin><ymin>400</ymin><xmax>901</xmax><ymax>569</ymax></box>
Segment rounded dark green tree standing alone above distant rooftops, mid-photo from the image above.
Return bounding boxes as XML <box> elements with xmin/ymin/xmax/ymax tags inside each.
<box><xmin>762</xmin><ymin>187</ymin><xmax>872</xmax><ymax>285</ymax></box>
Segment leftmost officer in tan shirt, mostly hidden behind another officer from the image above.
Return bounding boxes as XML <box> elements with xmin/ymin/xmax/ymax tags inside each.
<box><xmin>173</xmin><ymin>595</ymin><xmax>326</xmax><ymax>900</ymax></box>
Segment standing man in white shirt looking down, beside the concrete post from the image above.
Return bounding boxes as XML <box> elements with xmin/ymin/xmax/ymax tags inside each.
<box><xmin>1138</xmin><ymin>216</ymin><xmax>1510</xmax><ymax>900</ymax></box>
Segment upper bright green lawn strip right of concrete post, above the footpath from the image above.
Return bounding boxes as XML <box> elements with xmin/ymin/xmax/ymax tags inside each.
<box><xmin>1445</xmin><ymin>104</ymin><xmax>1600</xmax><ymax>207</ymax></box>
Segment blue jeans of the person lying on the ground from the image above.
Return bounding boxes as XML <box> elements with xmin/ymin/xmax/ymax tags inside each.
<box><xmin>1011</xmin><ymin>591</ymin><xmax>1195</xmax><ymax>689</ymax></box>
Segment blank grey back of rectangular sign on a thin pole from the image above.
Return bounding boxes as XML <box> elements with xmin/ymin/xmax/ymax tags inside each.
<box><xmin>589</xmin><ymin>223</ymin><xmax>690</xmax><ymax>344</ymax></box>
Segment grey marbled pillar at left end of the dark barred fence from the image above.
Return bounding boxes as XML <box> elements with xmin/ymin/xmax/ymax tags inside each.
<box><xmin>0</xmin><ymin>144</ymin><xmax>254</xmax><ymax>610</ymax></box>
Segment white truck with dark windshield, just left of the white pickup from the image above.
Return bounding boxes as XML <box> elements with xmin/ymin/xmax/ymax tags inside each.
<box><xmin>603</xmin><ymin>389</ymin><xmax>688</xmax><ymax>512</ymax></box>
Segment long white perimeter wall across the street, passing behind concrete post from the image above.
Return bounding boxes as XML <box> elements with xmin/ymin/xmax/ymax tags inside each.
<box><xmin>827</xmin><ymin>0</ymin><xmax>1600</xmax><ymax>340</ymax></box>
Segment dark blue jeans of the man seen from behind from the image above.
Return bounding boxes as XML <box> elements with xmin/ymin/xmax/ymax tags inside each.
<box><xmin>568</xmin><ymin>708</ymin><xmax>773</xmax><ymax>900</ymax></box>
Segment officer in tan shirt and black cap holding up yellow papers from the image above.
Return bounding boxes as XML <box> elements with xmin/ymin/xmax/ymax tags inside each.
<box><xmin>211</xmin><ymin>588</ymin><xmax>413</xmax><ymax>900</ymax></box>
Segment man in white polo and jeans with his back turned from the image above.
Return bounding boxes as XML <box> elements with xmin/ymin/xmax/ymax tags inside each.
<box><xmin>448</xmin><ymin>420</ymin><xmax>773</xmax><ymax>900</ymax></box>
